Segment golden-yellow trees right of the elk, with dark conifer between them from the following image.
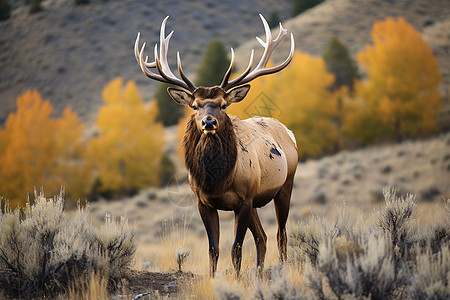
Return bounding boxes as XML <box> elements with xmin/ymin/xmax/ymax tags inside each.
<box><xmin>228</xmin><ymin>18</ymin><xmax>442</xmax><ymax>157</ymax></box>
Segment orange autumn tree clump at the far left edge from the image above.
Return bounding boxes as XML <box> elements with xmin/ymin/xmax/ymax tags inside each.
<box><xmin>0</xmin><ymin>90</ymin><xmax>90</xmax><ymax>205</ymax></box>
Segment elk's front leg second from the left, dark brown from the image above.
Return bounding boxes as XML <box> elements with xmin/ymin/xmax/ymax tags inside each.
<box><xmin>231</xmin><ymin>203</ymin><xmax>252</xmax><ymax>277</ymax></box>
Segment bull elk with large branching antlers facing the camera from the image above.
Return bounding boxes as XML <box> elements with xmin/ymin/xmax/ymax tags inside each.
<box><xmin>134</xmin><ymin>15</ymin><xmax>298</xmax><ymax>277</ymax></box>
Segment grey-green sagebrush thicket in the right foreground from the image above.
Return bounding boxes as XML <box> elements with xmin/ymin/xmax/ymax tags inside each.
<box><xmin>215</xmin><ymin>187</ymin><xmax>450</xmax><ymax>299</ymax></box>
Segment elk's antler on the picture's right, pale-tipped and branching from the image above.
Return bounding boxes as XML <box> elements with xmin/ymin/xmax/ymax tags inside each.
<box><xmin>220</xmin><ymin>14</ymin><xmax>295</xmax><ymax>91</ymax></box>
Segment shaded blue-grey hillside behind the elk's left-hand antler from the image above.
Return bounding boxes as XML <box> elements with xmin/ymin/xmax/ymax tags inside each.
<box><xmin>0</xmin><ymin>0</ymin><xmax>291</xmax><ymax>124</ymax></box>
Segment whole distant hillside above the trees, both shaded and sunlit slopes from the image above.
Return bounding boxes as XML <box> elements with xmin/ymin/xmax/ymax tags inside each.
<box><xmin>0</xmin><ymin>0</ymin><xmax>450</xmax><ymax>124</ymax></box>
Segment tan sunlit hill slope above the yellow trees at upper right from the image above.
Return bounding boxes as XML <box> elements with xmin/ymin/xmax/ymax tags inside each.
<box><xmin>236</xmin><ymin>0</ymin><xmax>450</xmax><ymax>128</ymax></box>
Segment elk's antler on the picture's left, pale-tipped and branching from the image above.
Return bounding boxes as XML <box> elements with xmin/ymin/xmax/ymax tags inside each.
<box><xmin>134</xmin><ymin>16</ymin><xmax>197</xmax><ymax>92</ymax></box>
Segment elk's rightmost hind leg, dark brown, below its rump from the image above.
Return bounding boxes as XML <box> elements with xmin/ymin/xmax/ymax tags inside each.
<box><xmin>274</xmin><ymin>175</ymin><xmax>294</xmax><ymax>262</ymax></box>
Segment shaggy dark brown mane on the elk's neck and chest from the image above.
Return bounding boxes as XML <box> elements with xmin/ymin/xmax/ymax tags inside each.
<box><xmin>183</xmin><ymin>115</ymin><xmax>237</xmax><ymax>194</ymax></box>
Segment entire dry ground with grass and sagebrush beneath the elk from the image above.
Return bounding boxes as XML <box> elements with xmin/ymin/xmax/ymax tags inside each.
<box><xmin>0</xmin><ymin>133</ymin><xmax>450</xmax><ymax>299</ymax></box>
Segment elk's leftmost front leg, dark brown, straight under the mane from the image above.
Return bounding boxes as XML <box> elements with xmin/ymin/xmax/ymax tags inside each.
<box><xmin>198</xmin><ymin>200</ymin><xmax>220</xmax><ymax>277</ymax></box>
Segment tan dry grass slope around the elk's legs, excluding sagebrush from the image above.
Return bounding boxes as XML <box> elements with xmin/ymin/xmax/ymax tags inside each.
<box><xmin>79</xmin><ymin>133</ymin><xmax>450</xmax><ymax>299</ymax></box>
